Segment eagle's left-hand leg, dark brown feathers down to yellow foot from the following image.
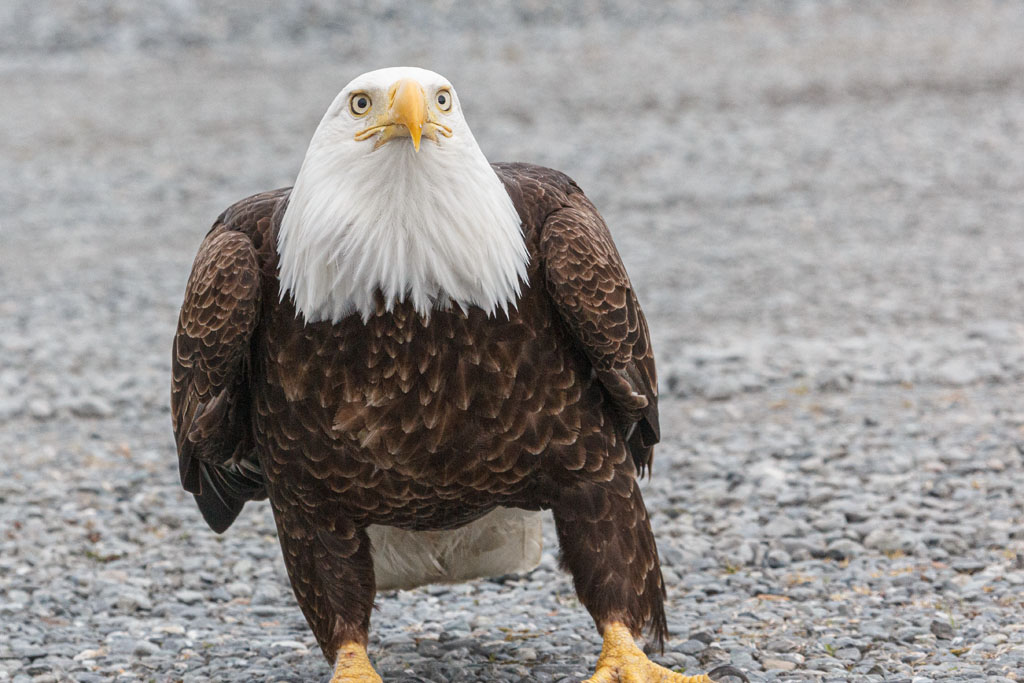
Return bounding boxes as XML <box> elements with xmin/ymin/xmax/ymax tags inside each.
<box><xmin>274</xmin><ymin>513</ymin><xmax>381</xmax><ymax>683</ymax></box>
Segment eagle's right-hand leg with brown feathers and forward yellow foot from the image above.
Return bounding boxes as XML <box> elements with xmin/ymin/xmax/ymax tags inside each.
<box><xmin>552</xmin><ymin>468</ymin><xmax>724</xmax><ymax>683</ymax></box>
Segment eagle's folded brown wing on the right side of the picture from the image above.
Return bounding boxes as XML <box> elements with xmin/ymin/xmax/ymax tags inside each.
<box><xmin>540</xmin><ymin>185</ymin><xmax>660</xmax><ymax>474</ymax></box>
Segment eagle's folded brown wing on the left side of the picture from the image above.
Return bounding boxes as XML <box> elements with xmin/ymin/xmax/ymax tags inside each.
<box><xmin>171</xmin><ymin>196</ymin><xmax>276</xmax><ymax>532</ymax></box>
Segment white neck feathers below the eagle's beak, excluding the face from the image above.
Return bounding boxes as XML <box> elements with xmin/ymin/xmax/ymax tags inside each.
<box><xmin>278</xmin><ymin>136</ymin><xmax>529</xmax><ymax>323</ymax></box>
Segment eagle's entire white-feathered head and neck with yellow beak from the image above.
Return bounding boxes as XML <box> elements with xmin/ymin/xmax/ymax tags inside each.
<box><xmin>278</xmin><ymin>67</ymin><xmax>529</xmax><ymax>322</ymax></box>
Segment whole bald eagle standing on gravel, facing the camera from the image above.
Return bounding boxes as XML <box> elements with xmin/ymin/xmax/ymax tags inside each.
<box><xmin>171</xmin><ymin>68</ymin><xmax>729</xmax><ymax>683</ymax></box>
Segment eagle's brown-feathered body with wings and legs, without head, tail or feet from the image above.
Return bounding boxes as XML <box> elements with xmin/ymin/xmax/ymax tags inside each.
<box><xmin>172</xmin><ymin>165</ymin><xmax>665</xmax><ymax>658</ymax></box>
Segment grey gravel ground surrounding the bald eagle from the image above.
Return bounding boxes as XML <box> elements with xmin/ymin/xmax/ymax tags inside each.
<box><xmin>0</xmin><ymin>0</ymin><xmax>1024</xmax><ymax>683</ymax></box>
